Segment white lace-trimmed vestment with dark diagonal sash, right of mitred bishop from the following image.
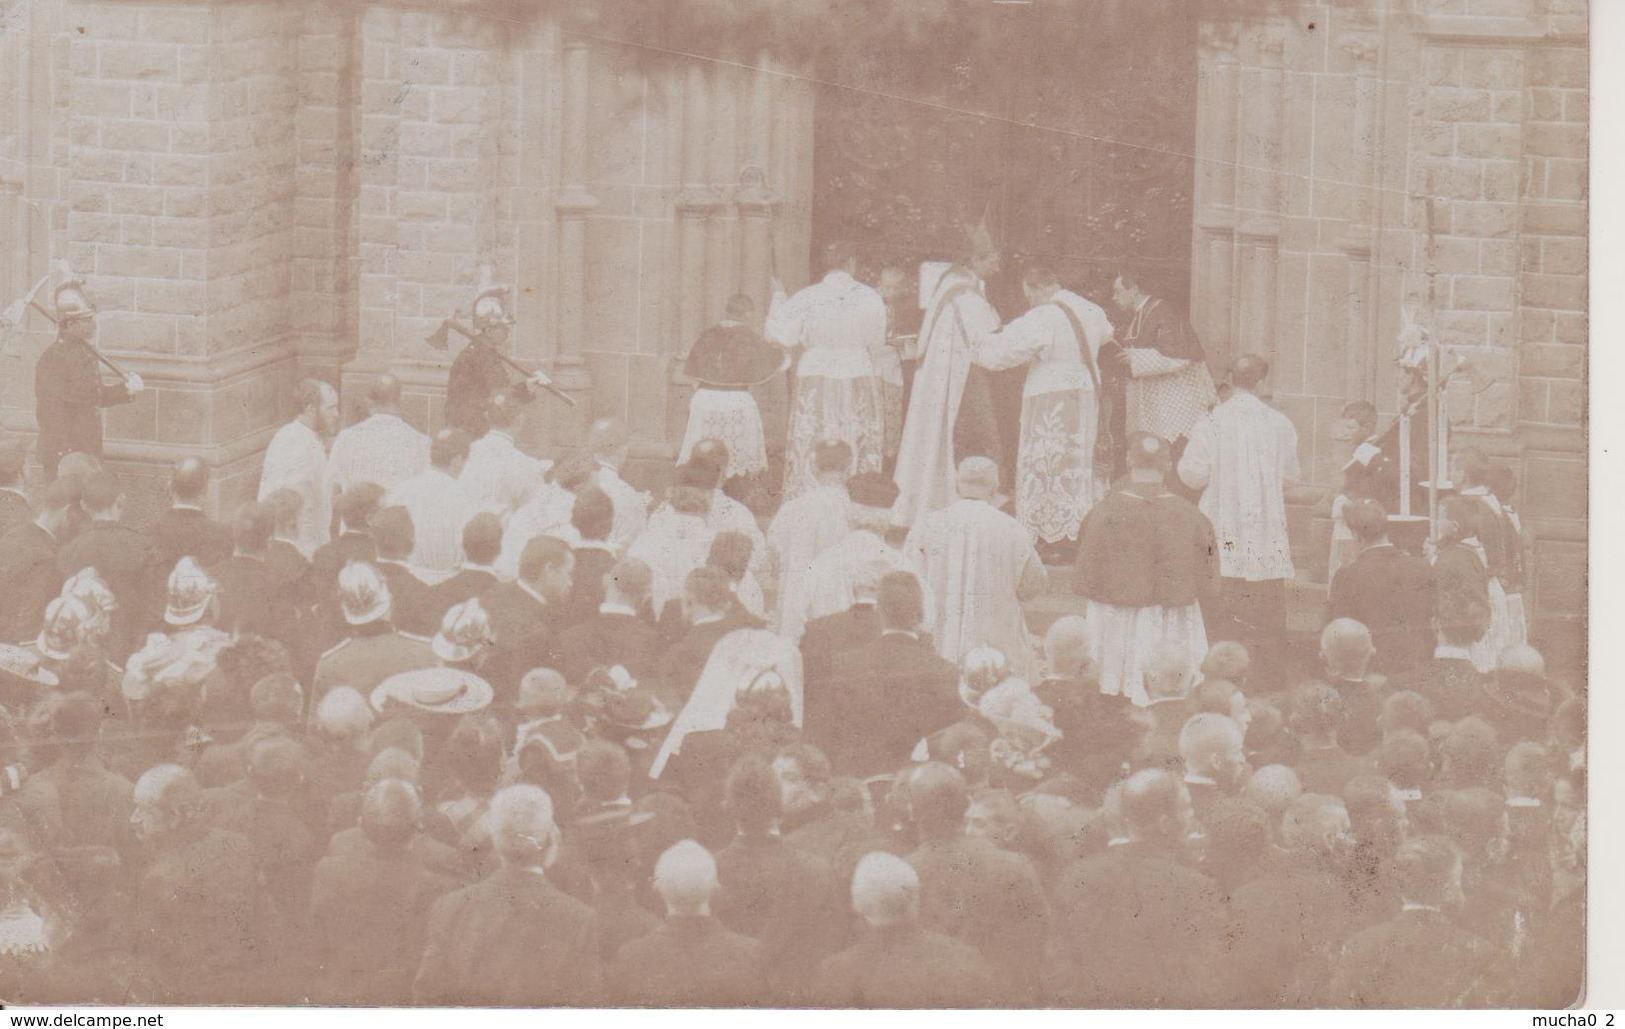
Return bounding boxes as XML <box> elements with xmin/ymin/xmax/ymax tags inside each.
<box><xmin>975</xmin><ymin>289</ymin><xmax>1112</xmax><ymax>543</ymax></box>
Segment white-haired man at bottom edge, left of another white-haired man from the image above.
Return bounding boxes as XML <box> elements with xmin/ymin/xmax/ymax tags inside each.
<box><xmin>606</xmin><ymin>840</ymin><xmax>765</xmax><ymax>1008</ymax></box>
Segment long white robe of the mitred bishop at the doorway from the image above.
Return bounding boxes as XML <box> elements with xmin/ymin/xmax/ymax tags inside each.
<box><xmin>892</xmin><ymin>268</ymin><xmax>999</xmax><ymax>525</ymax></box>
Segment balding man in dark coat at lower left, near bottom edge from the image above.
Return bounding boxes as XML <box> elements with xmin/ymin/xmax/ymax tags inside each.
<box><xmin>133</xmin><ymin>764</ymin><xmax>271</xmax><ymax>1005</ymax></box>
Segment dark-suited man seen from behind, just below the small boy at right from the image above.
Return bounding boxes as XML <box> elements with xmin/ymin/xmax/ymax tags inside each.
<box><xmin>1326</xmin><ymin>501</ymin><xmax>1433</xmax><ymax>676</ymax></box>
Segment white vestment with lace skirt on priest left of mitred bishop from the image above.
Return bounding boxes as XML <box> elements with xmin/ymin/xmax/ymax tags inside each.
<box><xmin>762</xmin><ymin>271</ymin><xmax>886</xmax><ymax>499</ymax></box>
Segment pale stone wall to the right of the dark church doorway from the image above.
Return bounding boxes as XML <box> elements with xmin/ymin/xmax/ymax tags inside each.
<box><xmin>1193</xmin><ymin>0</ymin><xmax>1588</xmax><ymax>665</ymax></box>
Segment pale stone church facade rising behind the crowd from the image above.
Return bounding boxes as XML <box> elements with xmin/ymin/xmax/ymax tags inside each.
<box><xmin>0</xmin><ymin>0</ymin><xmax>1589</xmax><ymax>663</ymax></box>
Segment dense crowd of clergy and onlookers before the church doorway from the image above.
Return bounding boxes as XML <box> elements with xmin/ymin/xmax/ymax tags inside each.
<box><xmin>0</xmin><ymin>245</ymin><xmax>1586</xmax><ymax>1008</ymax></box>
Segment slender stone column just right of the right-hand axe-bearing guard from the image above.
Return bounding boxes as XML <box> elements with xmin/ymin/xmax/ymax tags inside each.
<box><xmin>553</xmin><ymin>33</ymin><xmax>598</xmax><ymax>429</ymax></box>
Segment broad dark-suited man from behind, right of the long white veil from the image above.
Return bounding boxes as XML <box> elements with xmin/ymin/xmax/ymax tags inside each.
<box><xmin>804</xmin><ymin>572</ymin><xmax>965</xmax><ymax>779</ymax></box>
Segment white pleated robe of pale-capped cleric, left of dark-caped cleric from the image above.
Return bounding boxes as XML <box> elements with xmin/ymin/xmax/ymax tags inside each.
<box><xmin>904</xmin><ymin>497</ymin><xmax>1045</xmax><ymax>676</ymax></box>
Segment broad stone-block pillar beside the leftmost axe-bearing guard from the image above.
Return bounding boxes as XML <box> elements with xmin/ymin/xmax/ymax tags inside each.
<box><xmin>52</xmin><ymin>0</ymin><xmax>299</xmax><ymax>520</ymax></box>
